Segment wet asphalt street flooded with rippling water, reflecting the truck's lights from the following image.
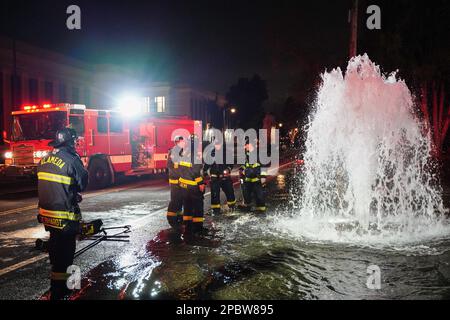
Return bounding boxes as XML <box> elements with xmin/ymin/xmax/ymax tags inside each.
<box><xmin>0</xmin><ymin>161</ymin><xmax>450</xmax><ymax>299</ymax></box>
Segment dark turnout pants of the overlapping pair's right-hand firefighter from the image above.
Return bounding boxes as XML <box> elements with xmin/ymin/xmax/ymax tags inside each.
<box><xmin>182</xmin><ymin>186</ymin><xmax>204</xmax><ymax>232</ymax></box>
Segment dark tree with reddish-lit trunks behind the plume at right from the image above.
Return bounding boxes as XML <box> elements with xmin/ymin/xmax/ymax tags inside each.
<box><xmin>359</xmin><ymin>0</ymin><xmax>450</xmax><ymax>158</ymax></box>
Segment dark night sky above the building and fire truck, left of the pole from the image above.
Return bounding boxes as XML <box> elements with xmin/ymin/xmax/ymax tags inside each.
<box><xmin>2</xmin><ymin>0</ymin><xmax>350</xmax><ymax>104</ymax></box>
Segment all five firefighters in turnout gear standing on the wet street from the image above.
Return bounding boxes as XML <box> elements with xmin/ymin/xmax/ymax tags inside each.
<box><xmin>38</xmin><ymin>128</ymin><xmax>266</xmax><ymax>300</ymax></box>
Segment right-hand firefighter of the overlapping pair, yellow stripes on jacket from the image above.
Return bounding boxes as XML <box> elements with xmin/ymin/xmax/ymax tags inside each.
<box><xmin>179</xmin><ymin>135</ymin><xmax>205</xmax><ymax>233</ymax></box>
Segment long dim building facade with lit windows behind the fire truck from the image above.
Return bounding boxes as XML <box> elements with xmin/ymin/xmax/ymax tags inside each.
<box><xmin>0</xmin><ymin>36</ymin><xmax>226</xmax><ymax>143</ymax></box>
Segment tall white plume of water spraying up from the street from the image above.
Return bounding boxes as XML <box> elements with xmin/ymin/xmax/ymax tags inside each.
<box><xmin>280</xmin><ymin>55</ymin><xmax>448</xmax><ymax>245</ymax></box>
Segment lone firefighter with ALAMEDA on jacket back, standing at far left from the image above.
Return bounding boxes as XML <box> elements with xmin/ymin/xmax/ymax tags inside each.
<box><xmin>37</xmin><ymin>128</ymin><xmax>88</xmax><ymax>300</ymax></box>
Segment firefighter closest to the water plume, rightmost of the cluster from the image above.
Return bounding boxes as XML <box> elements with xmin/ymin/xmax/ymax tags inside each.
<box><xmin>239</xmin><ymin>140</ymin><xmax>266</xmax><ymax>213</ymax></box>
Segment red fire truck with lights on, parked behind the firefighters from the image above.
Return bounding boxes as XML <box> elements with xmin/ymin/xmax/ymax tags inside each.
<box><xmin>2</xmin><ymin>103</ymin><xmax>201</xmax><ymax>188</ymax></box>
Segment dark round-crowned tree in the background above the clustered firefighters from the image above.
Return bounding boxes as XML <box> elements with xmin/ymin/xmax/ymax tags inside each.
<box><xmin>226</xmin><ymin>75</ymin><xmax>269</xmax><ymax>129</ymax></box>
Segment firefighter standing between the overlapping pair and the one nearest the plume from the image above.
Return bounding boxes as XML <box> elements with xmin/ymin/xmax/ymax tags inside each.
<box><xmin>204</xmin><ymin>140</ymin><xmax>236</xmax><ymax>215</ymax></box>
